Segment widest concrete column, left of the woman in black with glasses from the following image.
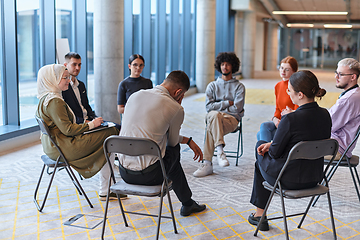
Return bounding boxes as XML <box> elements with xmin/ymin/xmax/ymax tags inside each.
<box><xmin>94</xmin><ymin>0</ymin><xmax>124</xmax><ymax>123</ymax></box>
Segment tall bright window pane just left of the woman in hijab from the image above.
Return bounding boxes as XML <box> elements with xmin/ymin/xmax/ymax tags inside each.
<box><xmin>16</xmin><ymin>0</ymin><xmax>40</xmax><ymax>121</ymax></box>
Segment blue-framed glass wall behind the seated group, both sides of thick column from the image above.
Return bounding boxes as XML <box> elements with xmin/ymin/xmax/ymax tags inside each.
<box><xmin>0</xmin><ymin>0</ymin><xmax>233</xmax><ymax>141</ymax></box>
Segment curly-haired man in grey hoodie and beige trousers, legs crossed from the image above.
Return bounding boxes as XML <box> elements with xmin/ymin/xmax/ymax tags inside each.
<box><xmin>193</xmin><ymin>52</ymin><xmax>245</xmax><ymax>177</ymax></box>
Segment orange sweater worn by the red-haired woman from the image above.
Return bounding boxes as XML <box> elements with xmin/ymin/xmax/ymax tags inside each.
<box><xmin>274</xmin><ymin>80</ymin><xmax>299</xmax><ymax>119</ymax></box>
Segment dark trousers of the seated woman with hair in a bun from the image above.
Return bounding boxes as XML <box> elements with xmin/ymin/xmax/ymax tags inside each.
<box><xmin>250</xmin><ymin>140</ymin><xmax>317</xmax><ymax>209</ymax></box>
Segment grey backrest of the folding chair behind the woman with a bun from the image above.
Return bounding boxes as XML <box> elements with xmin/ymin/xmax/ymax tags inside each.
<box><xmin>275</xmin><ymin>139</ymin><xmax>339</xmax><ymax>185</ymax></box>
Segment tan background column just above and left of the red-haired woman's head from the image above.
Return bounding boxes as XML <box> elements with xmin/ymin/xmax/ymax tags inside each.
<box><xmin>265</xmin><ymin>23</ymin><xmax>279</xmax><ymax>70</ymax></box>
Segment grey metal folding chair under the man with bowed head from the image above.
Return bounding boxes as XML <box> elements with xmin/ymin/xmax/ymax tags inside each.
<box><xmin>101</xmin><ymin>136</ymin><xmax>177</xmax><ymax>239</ymax></box>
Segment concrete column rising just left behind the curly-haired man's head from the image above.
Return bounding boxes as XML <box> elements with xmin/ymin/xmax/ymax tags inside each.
<box><xmin>195</xmin><ymin>0</ymin><xmax>216</xmax><ymax>92</ymax></box>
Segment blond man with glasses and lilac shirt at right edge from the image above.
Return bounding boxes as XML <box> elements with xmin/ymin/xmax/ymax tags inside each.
<box><xmin>329</xmin><ymin>58</ymin><xmax>360</xmax><ymax>159</ymax></box>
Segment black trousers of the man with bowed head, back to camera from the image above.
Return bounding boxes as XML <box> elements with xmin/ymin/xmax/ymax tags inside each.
<box><xmin>120</xmin><ymin>144</ymin><xmax>192</xmax><ymax>203</ymax></box>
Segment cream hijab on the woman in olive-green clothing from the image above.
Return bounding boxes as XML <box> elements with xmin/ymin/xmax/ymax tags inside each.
<box><xmin>37</xmin><ymin>64</ymin><xmax>66</xmax><ymax>106</ymax></box>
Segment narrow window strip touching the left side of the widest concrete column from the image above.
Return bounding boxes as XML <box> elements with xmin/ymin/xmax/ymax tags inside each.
<box><xmin>86</xmin><ymin>0</ymin><xmax>95</xmax><ymax>109</ymax></box>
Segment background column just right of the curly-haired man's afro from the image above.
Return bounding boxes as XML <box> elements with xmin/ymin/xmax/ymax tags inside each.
<box><xmin>241</xmin><ymin>6</ymin><xmax>256</xmax><ymax>78</ymax></box>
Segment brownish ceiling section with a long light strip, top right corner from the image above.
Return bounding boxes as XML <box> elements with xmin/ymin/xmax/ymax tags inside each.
<box><xmin>260</xmin><ymin>0</ymin><xmax>360</xmax><ymax>25</ymax></box>
